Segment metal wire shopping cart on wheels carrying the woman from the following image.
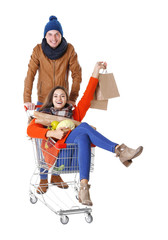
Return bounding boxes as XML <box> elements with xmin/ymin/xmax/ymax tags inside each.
<box><xmin>25</xmin><ymin>106</ymin><xmax>95</xmax><ymax>224</ymax></box>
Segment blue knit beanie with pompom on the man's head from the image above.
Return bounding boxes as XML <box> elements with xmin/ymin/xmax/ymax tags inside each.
<box><xmin>44</xmin><ymin>16</ymin><xmax>63</xmax><ymax>37</ymax></box>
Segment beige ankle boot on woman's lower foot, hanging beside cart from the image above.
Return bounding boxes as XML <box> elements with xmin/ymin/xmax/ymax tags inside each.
<box><xmin>78</xmin><ymin>183</ymin><xmax>93</xmax><ymax>206</ymax></box>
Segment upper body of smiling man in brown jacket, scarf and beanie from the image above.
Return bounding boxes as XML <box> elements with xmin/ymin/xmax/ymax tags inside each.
<box><xmin>24</xmin><ymin>16</ymin><xmax>82</xmax><ymax>110</ymax></box>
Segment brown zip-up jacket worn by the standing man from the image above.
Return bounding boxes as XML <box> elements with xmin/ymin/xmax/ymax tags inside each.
<box><xmin>24</xmin><ymin>43</ymin><xmax>82</xmax><ymax>103</ymax></box>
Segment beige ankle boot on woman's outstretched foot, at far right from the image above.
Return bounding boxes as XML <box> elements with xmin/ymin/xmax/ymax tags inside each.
<box><xmin>115</xmin><ymin>144</ymin><xmax>143</xmax><ymax>167</ymax></box>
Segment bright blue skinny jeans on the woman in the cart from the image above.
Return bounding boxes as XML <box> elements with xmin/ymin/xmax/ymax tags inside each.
<box><xmin>42</xmin><ymin>123</ymin><xmax>118</xmax><ymax>180</ymax></box>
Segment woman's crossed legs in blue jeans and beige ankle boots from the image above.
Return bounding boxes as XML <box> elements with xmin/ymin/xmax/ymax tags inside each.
<box><xmin>66</xmin><ymin>123</ymin><xmax>142</xmax><ymax>205</ymax></box>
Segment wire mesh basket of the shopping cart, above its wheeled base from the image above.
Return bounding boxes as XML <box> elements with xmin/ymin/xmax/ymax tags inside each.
<box><xmin>32</xmin><ymin>138</ymin><xmax>95</xmax><ymax>174</ymax></box>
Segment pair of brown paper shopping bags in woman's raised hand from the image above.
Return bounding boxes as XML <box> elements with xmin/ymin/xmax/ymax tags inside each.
<box><xmin>90</xmin><ymin>73</ymin><xmax>120</xmax><ymax>110</ymax></box>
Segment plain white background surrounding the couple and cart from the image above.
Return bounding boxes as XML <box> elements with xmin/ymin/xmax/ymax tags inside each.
<box><xmin>0</xmin><ymin>0</ymin><xmax>168</xmax><ymax>240</ymax></box>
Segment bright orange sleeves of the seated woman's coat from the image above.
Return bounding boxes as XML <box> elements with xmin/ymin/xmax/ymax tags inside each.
<box><xmin>27</xmin><ymin>77</ymin><xmax>98</xmax><ymax>143</ymax></box>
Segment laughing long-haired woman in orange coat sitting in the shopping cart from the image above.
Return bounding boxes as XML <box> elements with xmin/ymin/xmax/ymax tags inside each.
<box><xmin>27</xmin><ymin>62</ymin><xmax>143</xmax><ymax>206</ymax></box>
